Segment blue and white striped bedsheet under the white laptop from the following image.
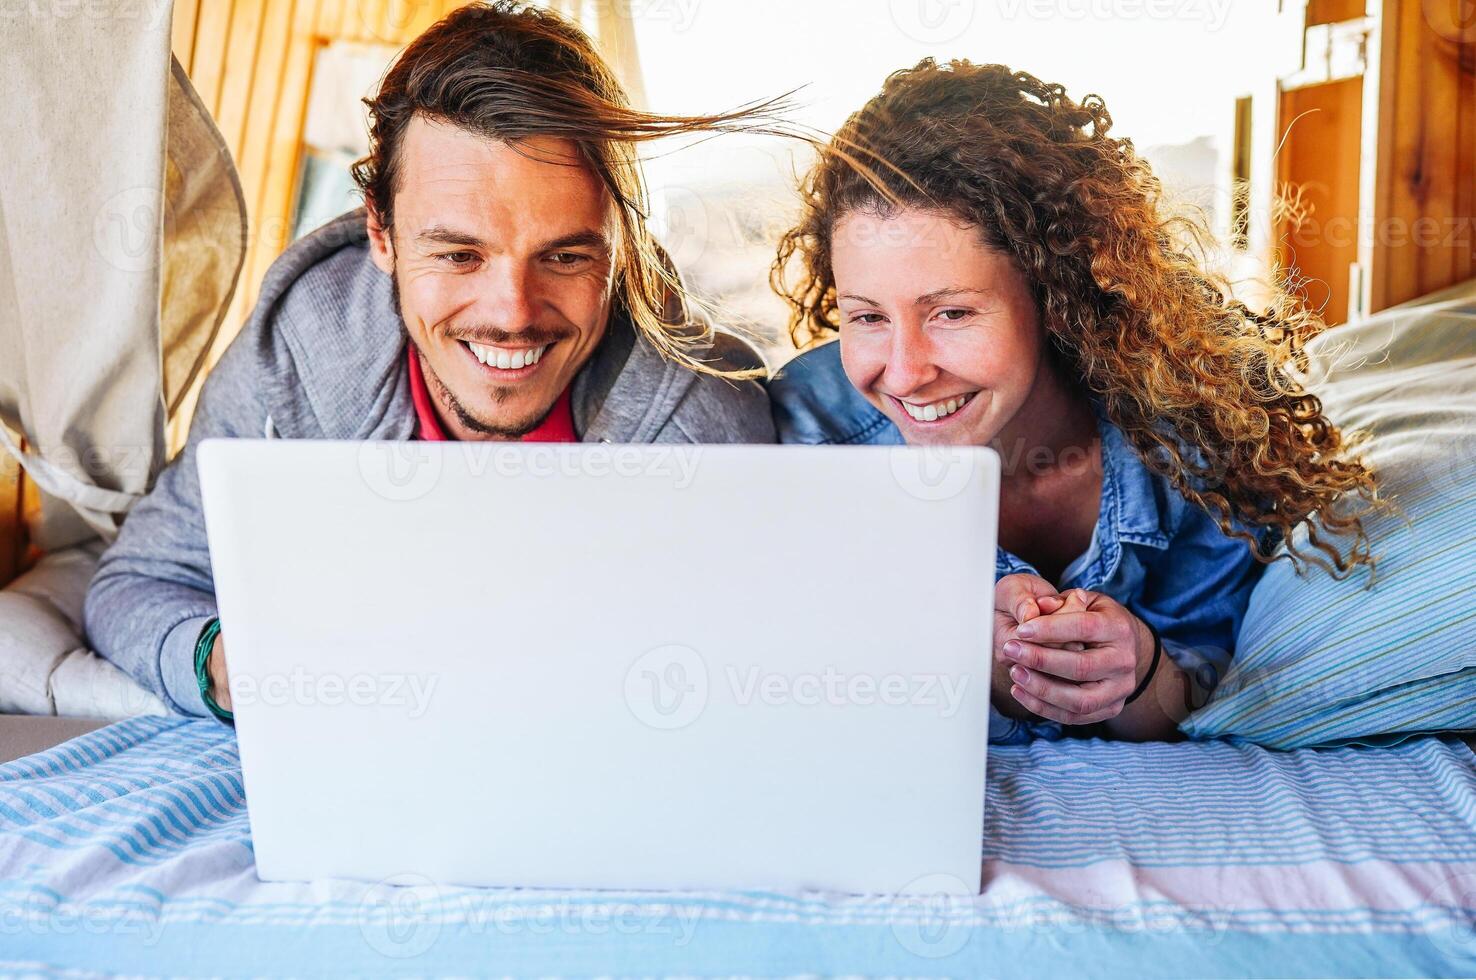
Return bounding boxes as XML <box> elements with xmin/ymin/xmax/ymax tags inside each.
<box><xmin>0</xmin><ymin>717</ymin><xmax>1476</xmax><ymax>977</ymax></box>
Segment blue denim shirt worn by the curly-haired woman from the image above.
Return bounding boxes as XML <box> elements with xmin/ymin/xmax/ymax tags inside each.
<box><xmin>769</xmin><ymin>344</ymin><xmax>1262</xmax><ymax>742</ymax></box>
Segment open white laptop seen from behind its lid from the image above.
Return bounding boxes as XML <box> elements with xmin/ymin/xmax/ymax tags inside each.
<box><xmin>198</xmin><ymin>440</ymin><xmax>999</xmax><ymax>894</ymax></box>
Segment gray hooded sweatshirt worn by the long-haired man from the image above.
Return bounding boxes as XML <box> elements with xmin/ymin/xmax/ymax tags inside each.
<box><xmin>84</xmin><ymin>210</ymin><xmax>775</xmax><ymax>714</ymax></box>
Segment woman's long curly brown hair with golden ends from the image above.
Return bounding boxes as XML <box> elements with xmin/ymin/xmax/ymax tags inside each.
<box><xmin>772</xmin><ymin>59</ymin><xmax>1379</xmax><ymax>576</ymax></box>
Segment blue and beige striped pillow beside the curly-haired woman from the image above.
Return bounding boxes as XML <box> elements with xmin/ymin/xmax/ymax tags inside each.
<box><xmin>1181</xmin><ymin>283</ymin><xmax>1476</xmax><ymax>748</ymax></box>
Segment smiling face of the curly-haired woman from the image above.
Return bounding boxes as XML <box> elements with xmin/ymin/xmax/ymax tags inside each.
<box><xmin>831</xmin><ymin>208</ymin><xmax>1046</xmax><ymax>446</ymax></box>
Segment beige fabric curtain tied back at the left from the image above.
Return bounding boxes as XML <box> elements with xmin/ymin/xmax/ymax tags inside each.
<box><xmin>0</xmin><ymin>11</ymin><xmax>246</xmax><ymax>551</ymax></box>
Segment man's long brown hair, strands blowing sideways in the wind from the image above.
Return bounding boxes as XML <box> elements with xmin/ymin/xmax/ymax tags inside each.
<box><xmin>353</xmin><ymin>0</ymin><xmax>785</xmax><ymax>376</ymax></box>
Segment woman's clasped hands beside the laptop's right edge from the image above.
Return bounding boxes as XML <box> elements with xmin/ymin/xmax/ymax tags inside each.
<box><xmin>996</xmin><ymin>590</ymin><xmax>1153</xmax><ymax>725</ymax></box>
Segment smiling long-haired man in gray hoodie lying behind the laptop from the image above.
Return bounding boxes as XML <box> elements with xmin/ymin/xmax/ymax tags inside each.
<box><xmin>86</xmin><ymin>0</ymin><xmax>773</xmax><ymax>717</ymax></box>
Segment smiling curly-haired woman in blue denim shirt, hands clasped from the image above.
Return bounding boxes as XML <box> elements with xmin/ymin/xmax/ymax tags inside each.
<box><xmin>770</xmin><ymin>59</ymin><xmax>1376</xmax><ymax>741</ymax></box>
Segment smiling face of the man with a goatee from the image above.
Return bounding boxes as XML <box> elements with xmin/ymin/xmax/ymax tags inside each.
<box><xmin>369</xmin><ymin>117</ymin><xmax>615</xmax><ymax>440</ymax></box>
